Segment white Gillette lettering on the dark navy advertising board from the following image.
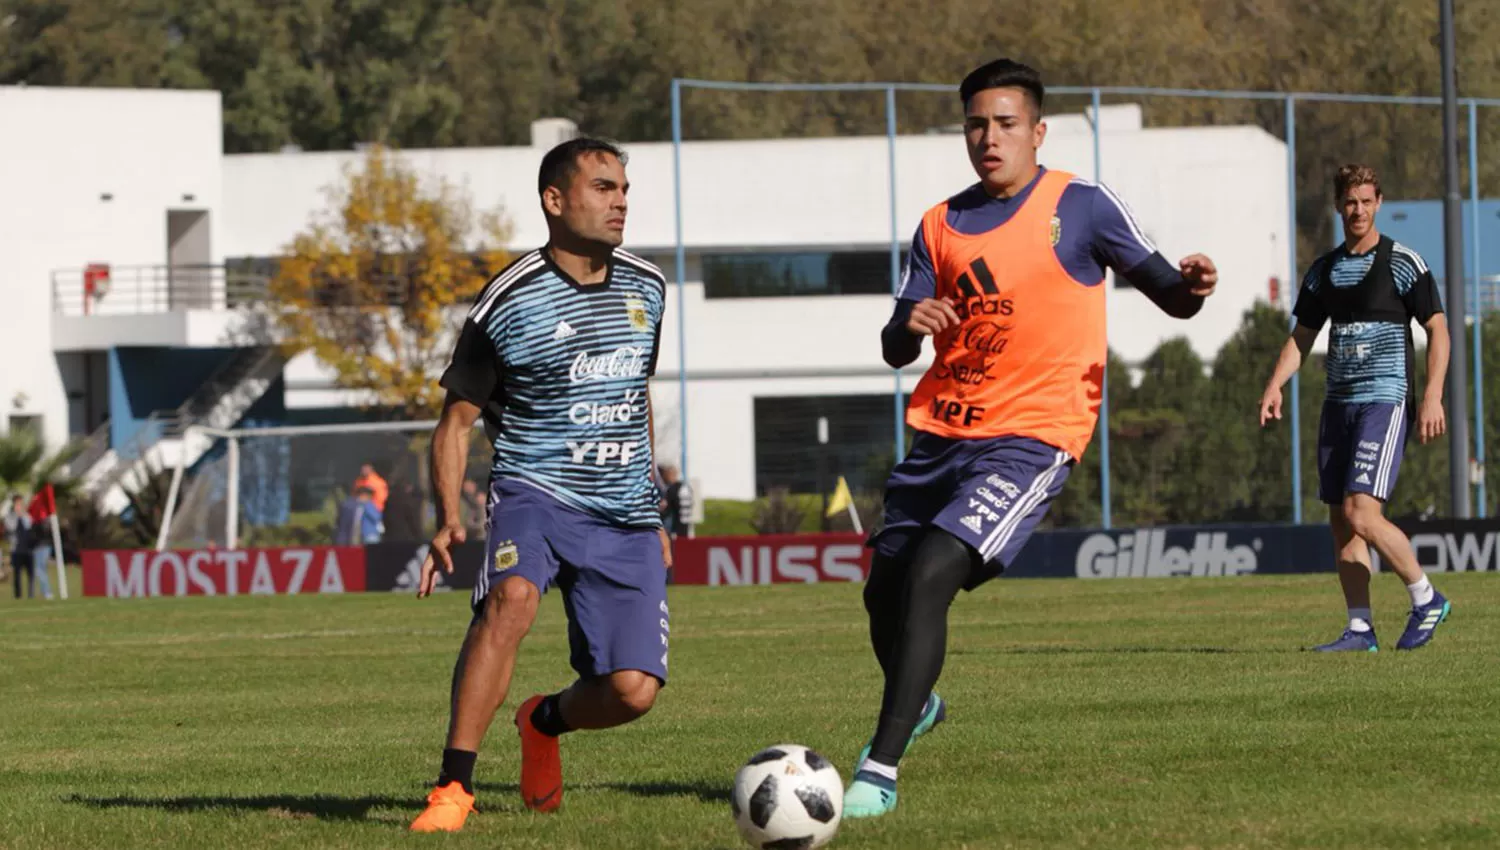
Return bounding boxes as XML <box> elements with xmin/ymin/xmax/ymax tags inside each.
<box><xmin>1074</xmin><ymin>528</ymin><xmax>1265</xmax><ymax>579</ymax></box>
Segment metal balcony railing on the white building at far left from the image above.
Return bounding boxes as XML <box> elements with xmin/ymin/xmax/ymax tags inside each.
<box><xmin>53</xmin><ymin>265</ymin><xmax>270</xmax><ymax>316</ymax></box>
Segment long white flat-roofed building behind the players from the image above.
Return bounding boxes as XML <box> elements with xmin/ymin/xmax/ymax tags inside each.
<box><xmin>0</xmin><ymin>87</ymin><xmax>1289</xmax><ymax>499</ymax></box>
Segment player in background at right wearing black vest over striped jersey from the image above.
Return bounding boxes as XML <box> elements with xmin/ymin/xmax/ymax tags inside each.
<box><xmin>1260</xmin><ymin>165</ymin><xmax>1452</xmax><ymax>652</ymax></box>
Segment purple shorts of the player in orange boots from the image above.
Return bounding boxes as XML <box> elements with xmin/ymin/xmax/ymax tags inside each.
<box><xmin>471</xmin><ymin>478</ymin><xmax>671</xmax><ymax>685</ymax></box>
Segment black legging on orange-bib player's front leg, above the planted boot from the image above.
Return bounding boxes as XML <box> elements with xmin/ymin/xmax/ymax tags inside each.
<box><xmin>870</xmin><ymin>529</ymin><xmax>978</xmax><ymax>766</ymax></box>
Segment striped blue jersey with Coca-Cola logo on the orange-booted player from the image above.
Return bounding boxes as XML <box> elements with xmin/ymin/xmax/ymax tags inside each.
<box><xmin>443</xmin><ymin>249</ymin><xmax>666</xmax><ymax>526</ymax></box>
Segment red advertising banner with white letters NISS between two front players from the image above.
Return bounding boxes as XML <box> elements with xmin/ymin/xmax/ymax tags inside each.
<box><xmin>672</xmin><ymin>534</ymin><xmax>870</xmax><ymax>585</ymax></box>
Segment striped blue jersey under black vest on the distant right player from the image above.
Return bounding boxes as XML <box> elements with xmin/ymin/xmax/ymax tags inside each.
<box><xmin>1296</xmin><ymin>243</ymin><xmax>1442</xmax><ymax>403</ymax></box>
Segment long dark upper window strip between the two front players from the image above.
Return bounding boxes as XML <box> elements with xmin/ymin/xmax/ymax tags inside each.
<box><xmin>704</xmin><ymin>249</ymin><xmax>906</xmax><ymax>298</ymax></box>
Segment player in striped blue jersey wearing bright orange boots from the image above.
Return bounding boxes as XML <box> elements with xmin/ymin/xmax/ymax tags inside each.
<box><xmin>411</xmin><ymin>138</ymin><xmax>672</xmax><ymax>832</ymax></box>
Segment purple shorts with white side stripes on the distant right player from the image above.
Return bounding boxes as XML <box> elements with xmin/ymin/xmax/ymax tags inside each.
<box><xmin>1317</xmin><ymin>402</ymin><xmax>1410</xmax><ymax>505</ymax></box>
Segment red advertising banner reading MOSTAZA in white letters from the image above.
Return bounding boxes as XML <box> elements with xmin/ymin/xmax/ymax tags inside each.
<box><xmin>83</xmin><ymin>546</ymin><xmax>365</xmax><ymax>598</ymax></box>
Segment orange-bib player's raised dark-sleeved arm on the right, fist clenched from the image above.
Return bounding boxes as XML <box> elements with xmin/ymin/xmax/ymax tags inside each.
<box><xmin>1089</xmin><ymin>184</ymin><xmax>1218</xmax><ymax>319</ymax></box>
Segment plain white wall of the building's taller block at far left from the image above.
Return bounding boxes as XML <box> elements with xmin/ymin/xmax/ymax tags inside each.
<box><xmin>0</xmin><ymin>87</ymin><xmax>224</xmax><ymax>444</ymax></box>
